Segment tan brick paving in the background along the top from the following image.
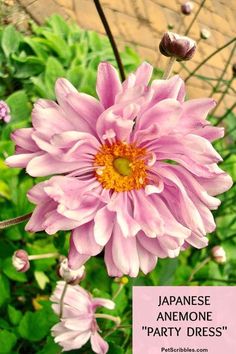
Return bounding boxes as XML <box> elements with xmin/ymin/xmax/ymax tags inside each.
<box><xmin>0</xmin><ymin>0</ymin><xmax>236</xmax><ymax>115</ymax></box>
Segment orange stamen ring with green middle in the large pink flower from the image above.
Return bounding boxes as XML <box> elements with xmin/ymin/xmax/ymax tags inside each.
<box><xmin>94</xmin><ymin>142</ymin><xmax>147</xmax><ymax>192</ymax></box>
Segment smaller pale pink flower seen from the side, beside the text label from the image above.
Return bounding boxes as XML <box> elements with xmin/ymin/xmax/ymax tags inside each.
<box><xmin>50</xmin><ymin>281</ymin><xmax>115</xmax><ymax>354</ymax></box>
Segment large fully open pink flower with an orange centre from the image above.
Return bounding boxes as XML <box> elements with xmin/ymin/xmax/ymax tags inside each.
<box><xmin>7</xmin><ymin>63</ymin><xmax>232</xmax><ymax>277</ymax></box>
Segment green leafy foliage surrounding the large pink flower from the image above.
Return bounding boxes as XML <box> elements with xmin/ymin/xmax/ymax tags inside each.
<box><xmin>0</xmin><ymin>15</ymin><xmax>236</xmax><ymax>354</ymax></box>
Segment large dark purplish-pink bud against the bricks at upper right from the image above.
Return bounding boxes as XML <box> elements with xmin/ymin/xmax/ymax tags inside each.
<box><xmin>159</xmin><ymin>32</ymin><xmax>196</xmax><ymax>61</ymax></box>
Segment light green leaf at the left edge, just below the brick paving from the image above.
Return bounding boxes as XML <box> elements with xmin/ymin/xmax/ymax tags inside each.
<box><xmin>2</xmin><ymin>25</ymin><xmax>20</xmax><ymax>57</ymax></box>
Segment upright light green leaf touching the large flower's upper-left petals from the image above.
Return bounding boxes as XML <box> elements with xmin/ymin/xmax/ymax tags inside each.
<box><xmin>45</xmin><ymin>57</ymin><xmax>65</xmax><ymax>98</ymax></box>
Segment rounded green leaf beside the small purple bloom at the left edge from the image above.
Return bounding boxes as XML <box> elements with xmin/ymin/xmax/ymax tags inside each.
<box><xmin>6</xmin><ymin>90</ymin><xmax>31</xmax><ymax>121</ymax></box>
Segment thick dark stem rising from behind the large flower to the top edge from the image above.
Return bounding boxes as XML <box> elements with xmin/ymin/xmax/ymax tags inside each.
<box><xmin>94</xmin><ymin>0</ymin><xmax>125</xmax><ymax>81</ymax></box>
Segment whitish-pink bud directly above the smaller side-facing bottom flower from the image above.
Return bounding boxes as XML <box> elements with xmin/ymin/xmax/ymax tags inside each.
<box><xmin>58</xmin><ymin>258</ymin><xmax>85</xmax><ymax>284</ymax></box>
